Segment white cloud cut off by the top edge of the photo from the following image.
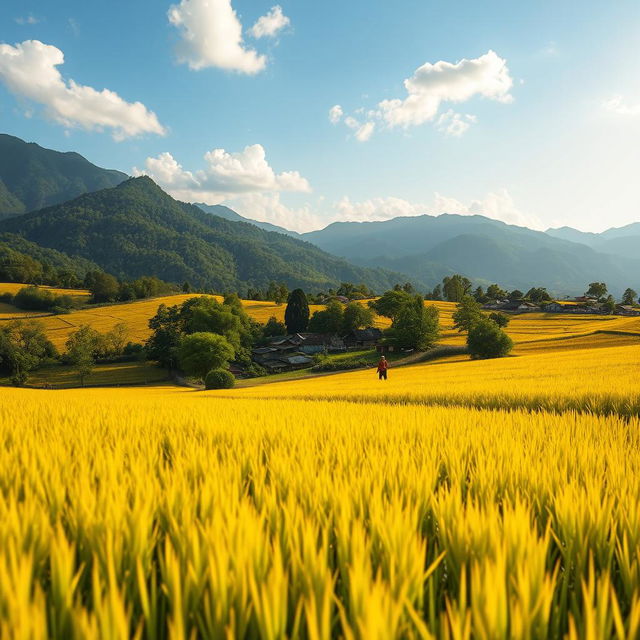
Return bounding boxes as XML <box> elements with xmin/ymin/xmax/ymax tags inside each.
<box><xmin>168</xmin><ymin>0</ymin><xmax>267</xmax><ymax>74</ymax></box>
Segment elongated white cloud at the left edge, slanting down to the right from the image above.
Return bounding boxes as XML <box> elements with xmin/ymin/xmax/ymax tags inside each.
<box><xmin>0</xmin><ymin>40</ymin><xmax>166</xmax><ymax>140</ymax></box>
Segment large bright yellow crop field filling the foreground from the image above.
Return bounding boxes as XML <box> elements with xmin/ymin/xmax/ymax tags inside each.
<box><xmin>0</xmin><ymin>384</ymin><xmax>640</xmax><ymax>640</ymax></box>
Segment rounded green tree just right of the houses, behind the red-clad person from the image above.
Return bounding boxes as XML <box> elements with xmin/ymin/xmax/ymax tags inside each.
<box><xmin>386</xmin><ymin>295</ymin><xmax>439</xmax><ymax>351</ymax></box>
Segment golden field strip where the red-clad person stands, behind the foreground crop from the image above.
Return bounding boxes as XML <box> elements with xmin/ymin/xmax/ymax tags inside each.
<box><xmin>226</xmin><ymin>335</ymin><xmax>640</xmax><ymax>412</ymax></box>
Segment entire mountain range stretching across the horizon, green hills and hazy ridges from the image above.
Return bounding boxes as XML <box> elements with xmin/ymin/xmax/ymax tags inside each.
<box><xmin>0</xmin><ymin>135</ymin><xmax>640</xmax><ymax>295</ymax></box>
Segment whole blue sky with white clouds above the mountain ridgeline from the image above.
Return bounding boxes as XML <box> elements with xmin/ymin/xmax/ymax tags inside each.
<box><xmin>0</xmin><ymin>0</ymin><xmax>640</xmax><ymax>231</ymax></box>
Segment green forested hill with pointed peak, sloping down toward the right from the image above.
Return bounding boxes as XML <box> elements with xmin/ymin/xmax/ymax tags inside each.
<box><xmin>0</xmin><ymin>177</ymin><xmax>410</xmax><ymax>291</ymax></box>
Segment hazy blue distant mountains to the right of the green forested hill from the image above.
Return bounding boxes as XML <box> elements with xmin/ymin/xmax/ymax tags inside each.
<box><xmin>302</xmin><ymin>214</ymin><xmax>640</xmax><ymax>294</ymax></box>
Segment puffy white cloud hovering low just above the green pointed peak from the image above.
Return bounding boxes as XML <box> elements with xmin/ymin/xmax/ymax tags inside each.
<box><xmin>133</xmin><ymin>144</ymin><xmax>311</xmax><ymax>204</ymax></box>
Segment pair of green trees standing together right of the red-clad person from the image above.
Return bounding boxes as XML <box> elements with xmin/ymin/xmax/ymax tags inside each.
<box><xmin>453</xmin><ymin>295</ymin><xmax>513</xmax><ymax>358</ymax></box>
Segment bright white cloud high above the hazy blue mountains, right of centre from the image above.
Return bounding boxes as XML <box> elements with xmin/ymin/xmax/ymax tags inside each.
<box><xmin>332</xmin><ymin>50</ymin><xmax>513</xmax><ymax>139</ymax></box>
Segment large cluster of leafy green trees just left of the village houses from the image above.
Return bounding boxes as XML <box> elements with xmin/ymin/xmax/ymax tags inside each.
<box><xmin>146</xmin><ymin>294</ymin><xmax>262</xmax><ymax>384</ymax></box>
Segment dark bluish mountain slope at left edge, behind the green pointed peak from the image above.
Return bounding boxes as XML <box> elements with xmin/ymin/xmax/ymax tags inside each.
<box><xmin>0</xmin><ymin>134</ymin><xmax>127</xmax><ymax>218</ymax></box>
